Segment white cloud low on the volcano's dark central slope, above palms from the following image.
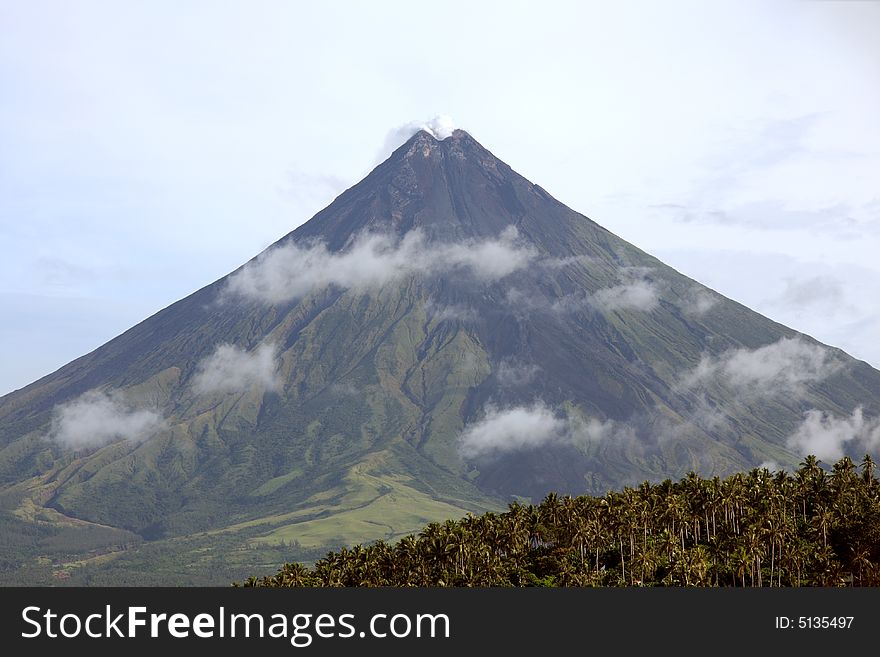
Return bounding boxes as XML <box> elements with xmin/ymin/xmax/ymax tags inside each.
<box><xmin>458</xmin><ymin>401</ymin><xmax>634</xmax><ymax>459</ymax></box>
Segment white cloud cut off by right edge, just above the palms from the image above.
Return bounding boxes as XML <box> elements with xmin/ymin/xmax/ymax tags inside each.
<box><xmin>786</xmin><ymin>406</ymin><xmax>880</xmax><ymax>461</ymax></box>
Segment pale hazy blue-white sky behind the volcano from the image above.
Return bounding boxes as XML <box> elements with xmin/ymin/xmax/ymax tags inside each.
<box><xmin>0</xmin><ymin>0</ymin><xmax>880</xmax><ymax>394</ymax></box>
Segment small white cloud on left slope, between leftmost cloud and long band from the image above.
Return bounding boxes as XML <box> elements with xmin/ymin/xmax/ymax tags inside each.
<box><xmin>193</xmin><ymin>343</ymin><xmax>281</xmax><ymax>394</ymax></box>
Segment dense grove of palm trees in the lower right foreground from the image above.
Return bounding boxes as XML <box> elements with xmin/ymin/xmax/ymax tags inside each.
<box><xmin>243</xmin><ymin>456</ymin><xmax>880</xmax><ymax>587</ymax></box>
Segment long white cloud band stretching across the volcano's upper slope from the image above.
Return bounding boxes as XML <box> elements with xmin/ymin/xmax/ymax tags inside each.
<box><xmin>225</xmin><ymin>226</ymin><xmax>536</xmax><ymax>303</ymax></box>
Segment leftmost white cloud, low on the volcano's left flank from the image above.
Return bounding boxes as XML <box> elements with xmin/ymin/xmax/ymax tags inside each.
<box><xmin>49</xmin><ymin>390</ymin><xmax>164</xmax><ymax>449</ymax></box>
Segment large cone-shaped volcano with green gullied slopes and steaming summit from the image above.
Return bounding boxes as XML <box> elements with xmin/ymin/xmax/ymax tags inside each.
<box><xmin>0</xmin><ymin>130</ymin><xmax>880</xmax><ymax>583</ymax></box>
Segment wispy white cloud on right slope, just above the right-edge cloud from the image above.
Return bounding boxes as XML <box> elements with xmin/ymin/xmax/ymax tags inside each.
<box><xmin>683</xmin><ymin>337</ymin><xmax>839</xmax><ymax>394</ymax></box>
